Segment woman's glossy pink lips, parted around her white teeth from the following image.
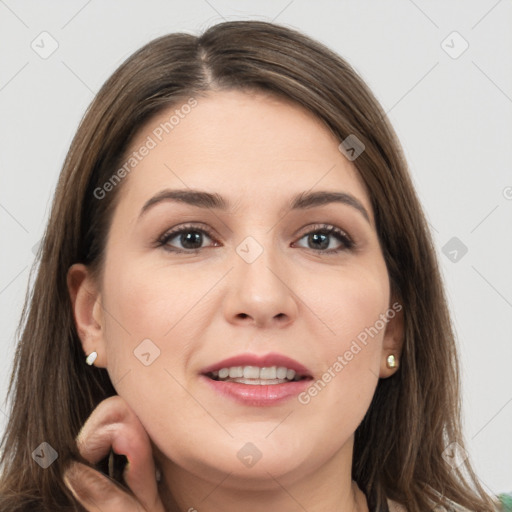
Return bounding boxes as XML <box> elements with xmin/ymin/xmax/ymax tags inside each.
<box><xmin>201</xmin><ymin>353</ymin><xmax>312</xmax><ymax>407</ymax></box>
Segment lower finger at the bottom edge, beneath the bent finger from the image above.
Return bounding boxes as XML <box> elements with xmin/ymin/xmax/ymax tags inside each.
<box><xmin>64</xmin><ymin>462</ymin><xmax>144</xmax><ymax>512</ymax></box>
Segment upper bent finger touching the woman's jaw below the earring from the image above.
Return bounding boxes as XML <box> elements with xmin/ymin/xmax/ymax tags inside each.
<box><xmin>77</xmin><ymin>396</ymin><xmax>163</xmax><ymax>511</ymax></box>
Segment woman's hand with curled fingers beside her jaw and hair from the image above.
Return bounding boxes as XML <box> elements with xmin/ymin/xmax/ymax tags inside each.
<box><xmin>64</xmin><ymin>396</ymin><xmax>165</xmax><ymax>512</ymax></box>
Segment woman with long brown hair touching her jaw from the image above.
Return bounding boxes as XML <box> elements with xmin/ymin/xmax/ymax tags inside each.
<box><xmin>0</xmin><ymin>21</ymin><xmax>506</xmax><ymax>512</ymax></box>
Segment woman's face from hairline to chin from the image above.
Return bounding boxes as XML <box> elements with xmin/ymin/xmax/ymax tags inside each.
<box><xmin>83</xmin><ymin>91</ymin><xmax>398</xmax><ymax>488</ymax></box>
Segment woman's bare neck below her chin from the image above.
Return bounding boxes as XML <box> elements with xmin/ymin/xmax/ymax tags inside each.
<box><xmin>154</xmin><ymin>443</ymin><xmax>368</xmax><ymax>512</ymax></box>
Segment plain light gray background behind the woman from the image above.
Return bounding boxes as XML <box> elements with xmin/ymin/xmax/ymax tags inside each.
<box><xmin>0</xmin><ymin>0</ymin><xmax>512</xmax><ymax>492</ymax></box>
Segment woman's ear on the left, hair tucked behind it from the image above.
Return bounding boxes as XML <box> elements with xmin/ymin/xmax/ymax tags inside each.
<box><xmin>67</xmin><ymin>263</ymin><xmax>107</xmax><ymax>368</ymax></box>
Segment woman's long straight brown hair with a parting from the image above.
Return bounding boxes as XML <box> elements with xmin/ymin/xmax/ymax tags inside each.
<box><xmin>0</xmin><ymin>21</ymin><xmax>496</xmax><ymax>512</ymax></box>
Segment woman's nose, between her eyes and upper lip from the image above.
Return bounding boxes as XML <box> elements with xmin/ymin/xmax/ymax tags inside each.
<box><xmin>223</xmin><ymin>237</ymin><xmax>298</xmax><ymax>328</ymax></box>
